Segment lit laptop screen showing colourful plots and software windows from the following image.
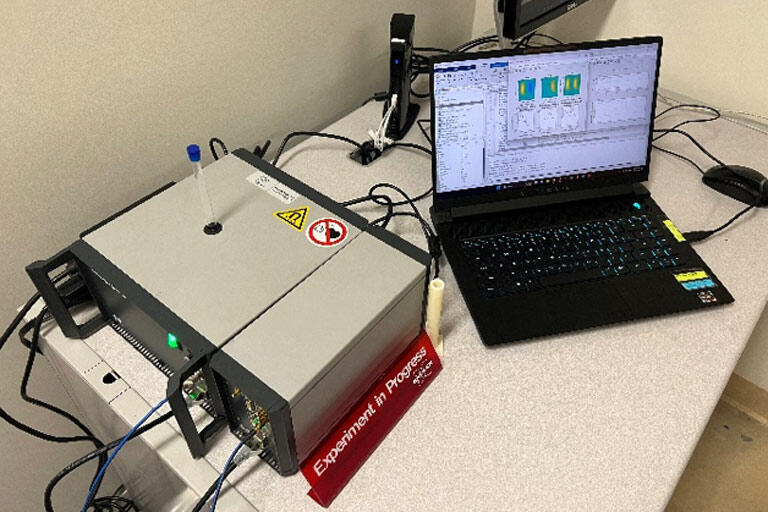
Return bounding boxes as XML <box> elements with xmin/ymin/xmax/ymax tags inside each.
<box><xmin>432</xmin><ymin>39</ymin><xmax>661</xmax><ymax>194</ymax></box>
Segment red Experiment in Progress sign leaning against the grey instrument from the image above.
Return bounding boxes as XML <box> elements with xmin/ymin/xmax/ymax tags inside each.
<box><xmin>301</xmin><ymin>332</ymin><xmax>442</xmax><ymax>507</ymax></box>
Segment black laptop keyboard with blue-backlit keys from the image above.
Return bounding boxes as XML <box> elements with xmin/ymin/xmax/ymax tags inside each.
<box><xmin>460</xmin><ymin>215</ymin><xmax>682</xmax><ymax>297</ymax></box>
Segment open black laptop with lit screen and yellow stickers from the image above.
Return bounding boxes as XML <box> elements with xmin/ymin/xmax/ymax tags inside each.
<box><xmin>430</xmin><ymin>37</ymin><xmax>733</xmax><ymax>345</ymax></box>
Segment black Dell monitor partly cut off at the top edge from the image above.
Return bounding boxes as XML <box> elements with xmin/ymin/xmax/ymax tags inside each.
<box><xmin>495</xmin><ymin>0</ymin><xmax>587</xmax><ymax>39</ymax></box>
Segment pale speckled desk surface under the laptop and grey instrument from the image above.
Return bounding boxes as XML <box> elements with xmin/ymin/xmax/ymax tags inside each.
<box><xmin>39</xmin><ymin>98</ymin><xmax>768</xmax><ymax>511</ymax></box>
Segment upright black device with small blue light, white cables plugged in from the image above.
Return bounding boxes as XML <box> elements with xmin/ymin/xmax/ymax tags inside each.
<box><xmin>384</xmin><ymin>13</ymin><xmax>419</xmax><ymax>140</ymax></box>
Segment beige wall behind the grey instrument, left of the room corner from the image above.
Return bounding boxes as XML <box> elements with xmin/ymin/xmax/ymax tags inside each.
<box><xmin>0</xmin><ymin>0</ymin><xmax>474</xmax><ymax>510</ymax></box>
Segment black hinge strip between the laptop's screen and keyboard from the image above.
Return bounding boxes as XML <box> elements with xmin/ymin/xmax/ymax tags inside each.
<box><xmin>450</xmin><ymin>183</ymin><xmax>650</xmax><ymax>219</ymax></box>
